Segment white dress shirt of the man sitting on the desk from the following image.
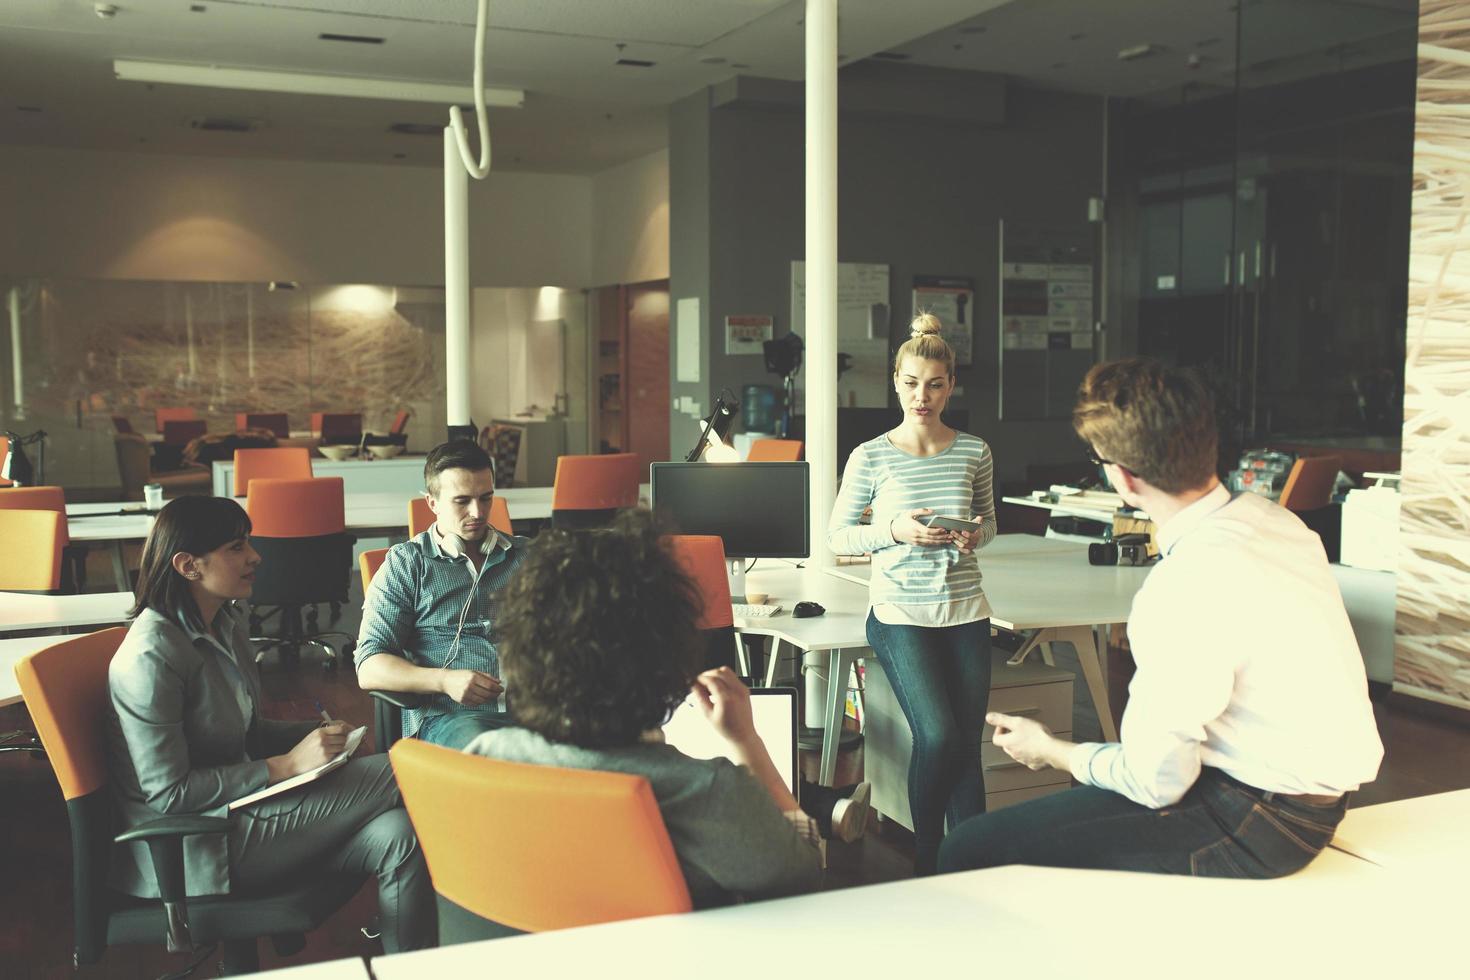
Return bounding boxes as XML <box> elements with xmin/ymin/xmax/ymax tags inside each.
<box><xmin>1069</xmin><ymin>486</ymin><xmax>1383</xmax><ymax>808</ymax></box>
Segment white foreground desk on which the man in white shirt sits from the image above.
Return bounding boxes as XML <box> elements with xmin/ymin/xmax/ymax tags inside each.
<box><xmin>372</xmin><ymin>851</ymin><xmax>1411</xmax><ymax>980</ymax></box>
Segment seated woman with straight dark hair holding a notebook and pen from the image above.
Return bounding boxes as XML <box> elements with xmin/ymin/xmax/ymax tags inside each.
<box><xmin>107</xmin><ymin>497</ymin><xmax>438</xmax><ymax>952</ymax></box>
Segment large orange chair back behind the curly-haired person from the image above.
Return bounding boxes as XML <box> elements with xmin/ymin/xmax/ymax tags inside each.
<box><xmin>388</xmin><ymin>739</ymin><xmax>691</xmax><ymax>945</ymax></box>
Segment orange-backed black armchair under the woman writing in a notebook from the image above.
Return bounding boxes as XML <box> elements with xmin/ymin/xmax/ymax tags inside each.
<box><xmin>16</xmin><ymin>626</ymin><xmax>366</xmax><ymax>977</ymax></box>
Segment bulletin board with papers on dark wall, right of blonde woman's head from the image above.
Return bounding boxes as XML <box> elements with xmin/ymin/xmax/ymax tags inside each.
<box><xmin>998</xmin><ymin>222</ymin><xmax>1098</xmax><ymax>422</ymax></box>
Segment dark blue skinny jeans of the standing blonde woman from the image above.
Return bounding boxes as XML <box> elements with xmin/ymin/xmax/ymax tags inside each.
<box><xmin>867</xmin><ymin>611</ymin><xmax>991</xmax><ymax>874</ymax></box>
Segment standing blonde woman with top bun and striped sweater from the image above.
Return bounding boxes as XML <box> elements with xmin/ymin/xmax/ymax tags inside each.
<box><xmin>828</xmin><ymin>313</ymin><xmax>995</xmax><ymax>874</ymax></box>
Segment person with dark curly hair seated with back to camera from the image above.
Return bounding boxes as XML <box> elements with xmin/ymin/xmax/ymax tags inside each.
<box><xmin>465</xmin><ymin>511</ymin><xmax>820</xmax><ymax>907</ymax></box>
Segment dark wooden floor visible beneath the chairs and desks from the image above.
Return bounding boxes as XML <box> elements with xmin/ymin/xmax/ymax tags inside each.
<box><xmin>0</xmin><ymin>549</ymin><xmax>1470</xmax><ymax>980</ymax></box>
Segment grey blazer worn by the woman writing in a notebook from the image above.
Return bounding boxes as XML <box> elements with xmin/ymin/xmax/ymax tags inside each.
<box><xmin>107</xmin><ymin>602</ymin><xmax>316</xmax><ymax>898</ymax></box>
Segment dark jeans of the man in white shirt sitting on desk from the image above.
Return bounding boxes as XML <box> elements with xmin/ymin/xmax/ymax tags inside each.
<box><xmin>939</xmin><ymin>767</ymin><xmax>1348</xmax><ymax>879</ymax></box>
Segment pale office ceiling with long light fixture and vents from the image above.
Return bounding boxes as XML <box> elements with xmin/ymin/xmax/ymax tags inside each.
<box><xmin>0</xmin><ymin>0</ymin><xmax>1414</xmax><ymax>173</ymax></box>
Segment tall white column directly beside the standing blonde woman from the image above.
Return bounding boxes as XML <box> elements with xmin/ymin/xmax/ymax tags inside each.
<box><xmin>803</xmin><ymin>0</ymin><xmax>836</xmax><ymax>567</ymax></box>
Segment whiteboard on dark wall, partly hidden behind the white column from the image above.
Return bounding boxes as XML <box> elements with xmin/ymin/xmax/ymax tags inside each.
<box><xmin>791</xmin><ymin>262</ymin><xmax>891</xmax><ymax>408</ymax></box>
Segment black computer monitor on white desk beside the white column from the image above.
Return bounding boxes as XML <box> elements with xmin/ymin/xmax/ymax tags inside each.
<box><xmin>650</xmin><ymin>463</ymin><xmax>811</xmax><ymax>558</ymax></box>
